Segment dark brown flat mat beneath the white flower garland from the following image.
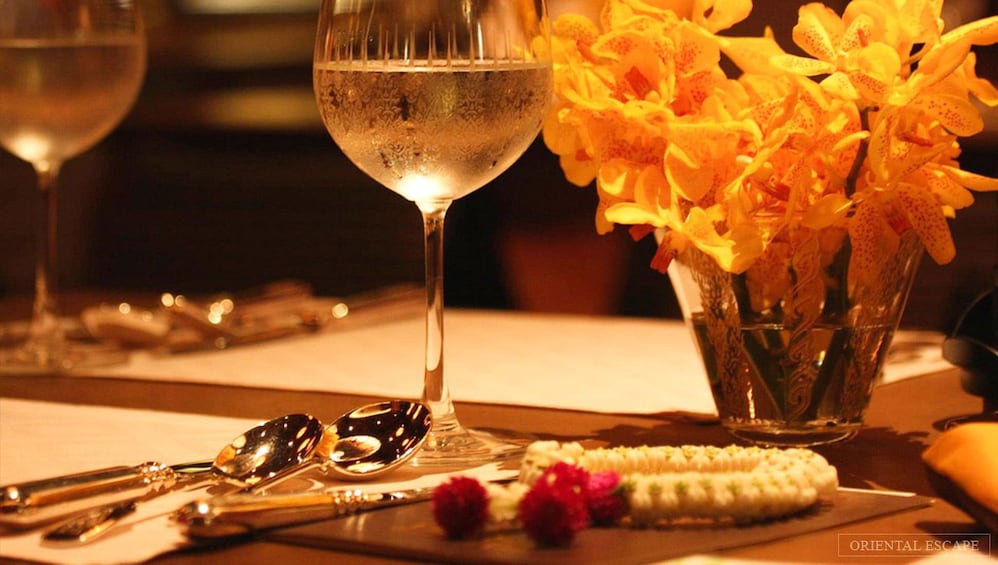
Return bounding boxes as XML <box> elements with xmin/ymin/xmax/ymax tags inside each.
<box><xmin>262</xmin><ymin>486</ymin><xmax>931</xmax><ymax>564</ymax></box>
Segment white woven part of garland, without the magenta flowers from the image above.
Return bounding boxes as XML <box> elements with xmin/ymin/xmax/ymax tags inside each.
<box><xmin>516</xmin><ymin>441</ymin><xmax>838</xmax><ymax>526</ymax></box>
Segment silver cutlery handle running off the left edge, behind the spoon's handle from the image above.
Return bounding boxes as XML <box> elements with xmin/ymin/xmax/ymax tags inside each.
<box><xmin>0</xmin><ymin>461</ymin><xmax>210</xmax><ymax>529</ymax></box>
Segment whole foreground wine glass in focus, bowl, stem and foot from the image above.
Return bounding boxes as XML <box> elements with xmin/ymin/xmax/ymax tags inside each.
<box><xmin>313</xmin><ymin>0</ymin><xmax>553</xmax><ymax>465</ymax></box>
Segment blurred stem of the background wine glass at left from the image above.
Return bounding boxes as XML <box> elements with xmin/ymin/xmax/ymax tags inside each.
<box><xmin>29</xmin><ymin>162</ymin><xmax>63</xmax><ymax>361</ymax></box>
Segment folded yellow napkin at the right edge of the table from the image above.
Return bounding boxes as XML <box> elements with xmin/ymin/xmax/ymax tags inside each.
<box><xmin>922</xmin><ymin>422</ymin><xmax>998</xmax><ymax>525</ymax></box>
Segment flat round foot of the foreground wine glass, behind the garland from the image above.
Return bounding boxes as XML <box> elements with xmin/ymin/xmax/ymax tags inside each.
<box><xmin>412</xmin><ymin>427</ymin><xmax>537</xmax><ymax>468</ymax></box>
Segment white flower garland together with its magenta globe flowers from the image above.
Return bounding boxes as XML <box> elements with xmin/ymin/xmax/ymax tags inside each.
<box><xmin>433</xmin><ymin>441</ymin><xmax>838</xmax><ymax>546</ymax></box>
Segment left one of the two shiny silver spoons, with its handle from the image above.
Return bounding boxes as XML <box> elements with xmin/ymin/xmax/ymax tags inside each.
<box><xmin>34</xmin><ymin>414</ymin><xmax>324</xmax><ymax>541</ymax></box>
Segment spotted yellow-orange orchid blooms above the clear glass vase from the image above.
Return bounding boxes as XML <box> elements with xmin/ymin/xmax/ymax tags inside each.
<box><xmin>543</xmin><ymin>0</ymin><xmax>998</xmax><ymax>282</ymax></box>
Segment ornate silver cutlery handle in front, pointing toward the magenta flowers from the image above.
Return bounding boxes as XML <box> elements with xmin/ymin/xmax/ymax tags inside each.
<box><xmin>173</xmin><ymin>487</ymin><xmax>433</xmax><ymax>539</ymax></box>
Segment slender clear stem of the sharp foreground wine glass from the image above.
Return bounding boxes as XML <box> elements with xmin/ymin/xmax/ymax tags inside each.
<box><xmin>417</xmin><ymin>201</ymin><xmax>459</xmax><ymax>433</ymax></box>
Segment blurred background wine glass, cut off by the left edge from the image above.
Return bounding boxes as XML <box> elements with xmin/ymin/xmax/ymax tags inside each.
<box><xmin>0</xmin><ymin>0</ymin><xmax>146</xmax><ymax>371</ymax></box>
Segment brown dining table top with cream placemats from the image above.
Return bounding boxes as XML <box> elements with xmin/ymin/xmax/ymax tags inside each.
<box><xmin>0</xmin><ymin>291</ymin><xmax>998</xmax><ymax>565</ymax></box>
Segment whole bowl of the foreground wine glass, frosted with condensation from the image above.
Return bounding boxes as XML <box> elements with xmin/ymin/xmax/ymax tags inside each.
<box><xmin>313</xmin><ymin>1</ymin><xmax>551</xmax><ymax>202</ymax></box>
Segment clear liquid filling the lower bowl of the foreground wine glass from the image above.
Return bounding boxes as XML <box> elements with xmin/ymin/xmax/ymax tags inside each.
<box><xmin>315</xmin><ymin>64</ymin><xmax>549</xmax><ymax>202</ymax></box>
